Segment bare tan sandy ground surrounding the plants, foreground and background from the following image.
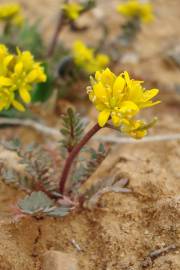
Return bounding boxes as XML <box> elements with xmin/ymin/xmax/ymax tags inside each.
<box><xmin>0</xmin><ymin>0</ymin><xmax>180</xmax><ymax>270</ymax></box>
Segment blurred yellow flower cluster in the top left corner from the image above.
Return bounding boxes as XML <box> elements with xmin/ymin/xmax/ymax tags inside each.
<box><xmin>0</xmin><ymin>4</ymin><xmax>24</xmax><ymax>26</ymax></box>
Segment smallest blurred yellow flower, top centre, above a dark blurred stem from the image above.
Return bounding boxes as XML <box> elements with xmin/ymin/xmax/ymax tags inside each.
<box><xmin>62</xmin><ymin>3</ymin><xmax>84</xmax><ymax>21</ymax></box>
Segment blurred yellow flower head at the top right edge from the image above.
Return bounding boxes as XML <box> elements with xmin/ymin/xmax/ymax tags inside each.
<box><xmin>117</xmin><ymin>0</ymin><xmax>154</xmax><ymax>22</ymax></box>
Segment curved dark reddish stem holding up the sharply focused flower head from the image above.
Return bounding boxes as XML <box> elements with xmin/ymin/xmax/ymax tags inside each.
<box><xmin>59</xmin><ymin>124</ymin><xmax>101</xmax><ymax>194</ymax></box>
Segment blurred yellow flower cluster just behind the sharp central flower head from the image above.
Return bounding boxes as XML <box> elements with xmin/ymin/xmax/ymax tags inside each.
<box><xmin>72</xmin><ymin>41</ymin><xmax>110</xmax><ymax>74</ymax></box>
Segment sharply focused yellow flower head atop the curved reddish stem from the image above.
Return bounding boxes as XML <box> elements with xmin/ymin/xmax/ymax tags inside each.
<box><xmin>87</xmin><ymin>68</ymin><xmax>159</xmax><ymax>138</ymax></box>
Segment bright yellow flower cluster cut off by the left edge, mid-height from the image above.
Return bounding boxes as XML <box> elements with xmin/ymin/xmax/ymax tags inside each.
<box><xmin>0</xmin><ymin>44</ymin><xmax>46</xmax><ymax>111</ymax></box>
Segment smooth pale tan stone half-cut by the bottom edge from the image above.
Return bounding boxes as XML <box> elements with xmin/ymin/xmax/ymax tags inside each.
<box><xmin>42</xmin><ymin>250</ymin><xmax>78</xmax><ymax>270</ymax></box>
